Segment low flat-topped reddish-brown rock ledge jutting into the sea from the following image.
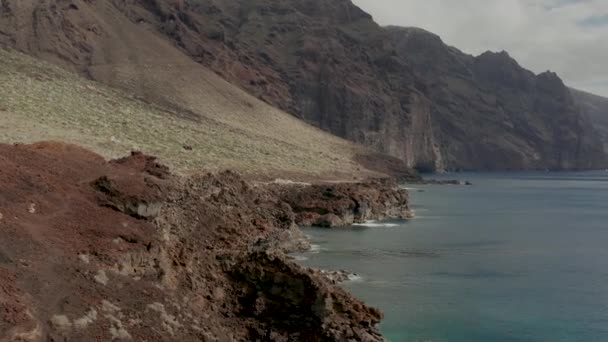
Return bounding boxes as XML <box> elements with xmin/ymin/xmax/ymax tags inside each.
<box><xmin>278</xmin><ymin>181</ymin><xmax>413</xmax><ymax>228</ymax></box>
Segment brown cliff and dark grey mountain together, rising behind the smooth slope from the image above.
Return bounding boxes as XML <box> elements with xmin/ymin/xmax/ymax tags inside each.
<box><xmin>150</xmin><ymin>0</ymin><xmax>605</xmax><ymax>169</ymax></box>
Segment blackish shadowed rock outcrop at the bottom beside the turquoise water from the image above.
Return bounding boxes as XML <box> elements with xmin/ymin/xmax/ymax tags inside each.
<box><xmin>232</xmin><ymin>253</ymin><xmax>383</xmax><ymax>342</ymax></box>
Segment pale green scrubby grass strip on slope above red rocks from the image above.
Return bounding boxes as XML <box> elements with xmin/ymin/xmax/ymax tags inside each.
<box><xmin>0</xmin><ymin>49</ymin><xmax>372</xmax><ymax>179</ymax></box>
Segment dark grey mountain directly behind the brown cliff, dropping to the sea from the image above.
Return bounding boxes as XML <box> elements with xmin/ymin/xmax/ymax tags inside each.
<box><xmin>387</xmin><ymin>27</ymin><xmax>606</xmax><ymax>169</ymax></box>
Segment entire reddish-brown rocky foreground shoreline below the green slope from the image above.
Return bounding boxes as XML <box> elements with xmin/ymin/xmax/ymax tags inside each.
<box><xmin>0</xmin><ymin>143</ymin><xmax>411</xmax><ymax>341</ymax></box>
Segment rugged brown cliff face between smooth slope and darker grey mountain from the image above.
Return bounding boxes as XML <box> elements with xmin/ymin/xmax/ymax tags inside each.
<box><xmin>163</xmin><ymin>0</ymin><xmax>443</xmax><ymax>168</ymax></box>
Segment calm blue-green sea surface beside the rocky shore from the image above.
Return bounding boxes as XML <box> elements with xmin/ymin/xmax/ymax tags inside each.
<box><xmin>300</xmin><ymin>172</ymin><xmax>608</xmax><ymax>342</ymax></box>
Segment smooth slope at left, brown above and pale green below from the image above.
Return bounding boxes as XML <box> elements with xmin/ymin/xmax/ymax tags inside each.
<box><xmin>0</xmin><ymin>0</ymin><xmax>414</xmax><ymax>180</ymax></box>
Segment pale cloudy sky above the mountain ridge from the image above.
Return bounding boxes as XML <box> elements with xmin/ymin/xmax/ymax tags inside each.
<box><xmin>354</xmin><ymin>0</ymin><xmax>608</xmax><ymax>96</ymax></box>
